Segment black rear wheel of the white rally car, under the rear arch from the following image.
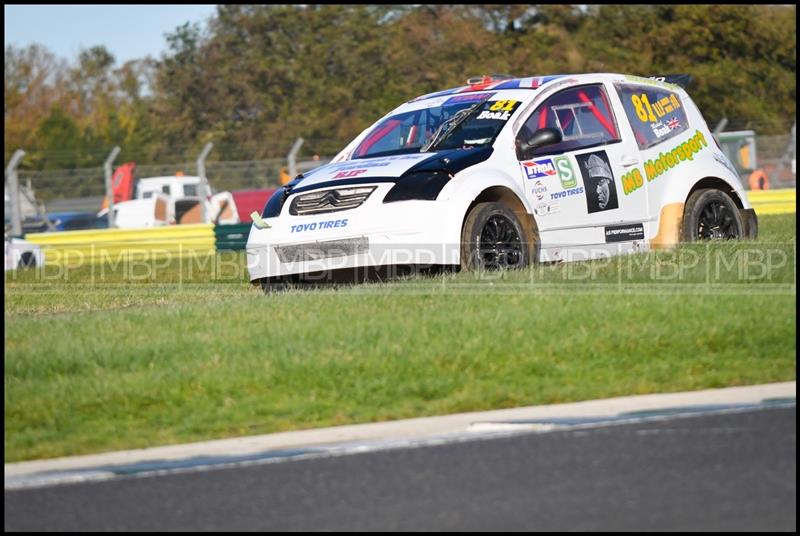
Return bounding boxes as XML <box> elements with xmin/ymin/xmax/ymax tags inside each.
<box><xmin>681</xmin><ymin>188</ymin><xmax>745</xmax><ymax>242</ymax></box>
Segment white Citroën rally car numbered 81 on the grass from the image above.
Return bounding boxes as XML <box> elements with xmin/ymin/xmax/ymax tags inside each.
<box><xmin>247</xmin><ymin>74</ymin><xmax>757</xmax><ymax>290</ymax></box>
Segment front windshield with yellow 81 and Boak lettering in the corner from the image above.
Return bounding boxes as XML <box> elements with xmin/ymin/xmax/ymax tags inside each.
<box><xmin>353</xmin><ymin>93</ymin><xmax>520</xmax><ymax>159</ymax></box>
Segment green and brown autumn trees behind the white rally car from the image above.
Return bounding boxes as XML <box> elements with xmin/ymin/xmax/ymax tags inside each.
<box><xmin>5</xmin><ymin>4</ymin><xmax>796</xmax><ymax>169</ymax></box>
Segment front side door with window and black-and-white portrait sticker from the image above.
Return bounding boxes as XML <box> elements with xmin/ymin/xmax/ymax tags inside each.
<box><xmin>517</xmin><ymin>83</ymin><xmax>648</xmax><ymax>250</ymax></box>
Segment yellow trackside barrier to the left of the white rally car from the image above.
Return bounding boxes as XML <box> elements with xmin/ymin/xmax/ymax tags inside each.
<box><xmin>25</xmin><ymin>223</ymin><xmax>216</xmax><ymax>265</ymax></box>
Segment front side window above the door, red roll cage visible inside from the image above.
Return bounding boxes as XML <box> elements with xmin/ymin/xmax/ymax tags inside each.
<box><xmin>517</xmin><ymin>84</ymin><xmax>620</xmax><ymax>160</ymax></box>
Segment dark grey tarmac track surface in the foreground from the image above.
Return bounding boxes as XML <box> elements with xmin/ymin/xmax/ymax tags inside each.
<box><xmin>5</xmin><ymin>407</ymin><xmax>797</xmax><ymax>531</ymax></box>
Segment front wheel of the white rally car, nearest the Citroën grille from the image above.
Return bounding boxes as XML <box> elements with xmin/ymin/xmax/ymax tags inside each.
<box><xmin>461</xmin><ymin>203</ymin><xmax>533</xmax><ymax>270</ymax></box>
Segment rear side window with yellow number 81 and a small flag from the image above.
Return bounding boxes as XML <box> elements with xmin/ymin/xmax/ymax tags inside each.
<box><xmin>616</xmin><ymin>84</ymin><xmax>689</xmax><ymax>149</ymax></box>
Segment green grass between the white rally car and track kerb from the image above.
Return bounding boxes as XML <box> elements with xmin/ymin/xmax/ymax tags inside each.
<box><xmin>5</xmin><ymin>215</ymin><xmax>796</xmax><ymax>462</ymax></box>
